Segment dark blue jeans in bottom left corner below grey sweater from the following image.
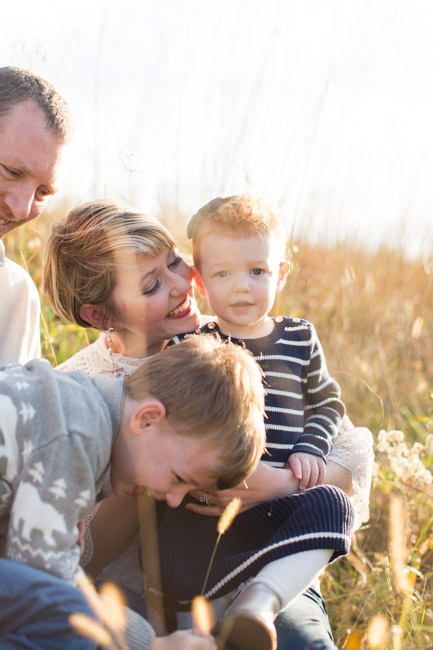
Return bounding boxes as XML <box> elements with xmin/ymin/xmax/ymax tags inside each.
<box><xmin>0</xmin><ymin>559</ymin><xmax>97</xmax><ymax>650</ymax></box>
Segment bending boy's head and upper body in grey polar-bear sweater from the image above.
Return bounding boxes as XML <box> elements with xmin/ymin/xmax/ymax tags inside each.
<box><xmin>0</xmin><ymin>337</ymin><xmax>264</xmax><ymax>647</ymax></box>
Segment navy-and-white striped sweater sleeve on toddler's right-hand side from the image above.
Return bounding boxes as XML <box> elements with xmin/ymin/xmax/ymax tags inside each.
<box><xmin>291</xmin><ymin>323</ymin><xmax>345</xmax><ymax>459</ymax></box>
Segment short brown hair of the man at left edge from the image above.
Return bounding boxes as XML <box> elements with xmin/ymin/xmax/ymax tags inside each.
<box><xmin>0</xmin><ymin>66</ymin><xmax>73</xmax><ymax>142</ymax></box>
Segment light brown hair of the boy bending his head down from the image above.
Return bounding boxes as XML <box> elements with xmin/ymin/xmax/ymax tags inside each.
<box><xmin>125</xmin><ymin>336</ymin><xmax>265</xmax><ymax>490</ymax></box>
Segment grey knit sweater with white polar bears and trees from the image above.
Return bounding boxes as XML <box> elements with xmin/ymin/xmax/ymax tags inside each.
<box><xmin>0</xmin><ymin>360</ymin><xmax>123</xmax><ymax>583</ymax></box>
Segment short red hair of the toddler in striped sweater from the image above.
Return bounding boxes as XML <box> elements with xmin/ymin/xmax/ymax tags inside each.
<box><xmin>187</xmin><ymin>194</ymin><xmax>287</xmax><ymax>270</ymax></box>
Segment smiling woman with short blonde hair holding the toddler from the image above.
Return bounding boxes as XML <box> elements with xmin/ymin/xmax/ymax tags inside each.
<box><xmin>44</xmin><ymin>201</ymin><xmax>371</xmax><ymax>648</ymax></box>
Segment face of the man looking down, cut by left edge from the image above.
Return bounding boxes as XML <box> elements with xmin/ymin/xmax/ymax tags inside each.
<box><xmin>0</xmin><ymin>100</ymin><xmax>64</xmax><ymax>239</ymax></box>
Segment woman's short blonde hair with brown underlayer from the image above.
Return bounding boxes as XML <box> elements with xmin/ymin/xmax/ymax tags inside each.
<box><xmin>43</xmin><ymin>200</ymin><xmax>175</xmax><ymax>327</ymax></box>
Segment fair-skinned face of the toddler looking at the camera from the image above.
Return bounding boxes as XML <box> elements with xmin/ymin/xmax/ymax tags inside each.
<box><xmin>194</xmin><ymin>229</ymin><xmax>286</xmax><ymax>338</ymax></box>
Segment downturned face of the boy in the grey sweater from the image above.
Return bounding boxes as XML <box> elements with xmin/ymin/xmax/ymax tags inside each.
<box><xmin>111</xmin><ymin>421</ymin><xmax>221</xmax><ymax>508</ymax></box>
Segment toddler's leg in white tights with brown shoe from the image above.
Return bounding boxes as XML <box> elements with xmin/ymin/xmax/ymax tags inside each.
<box><xmin>218</xmin><ymin>549</ymin><xmax>333</xmax><ymax>650</ymax></box>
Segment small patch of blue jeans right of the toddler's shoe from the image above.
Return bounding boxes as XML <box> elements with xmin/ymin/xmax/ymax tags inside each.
<box><xmin>275</xmin><ymin>587</ymin><xmax>337</xmax><ymax>650</ymax></box>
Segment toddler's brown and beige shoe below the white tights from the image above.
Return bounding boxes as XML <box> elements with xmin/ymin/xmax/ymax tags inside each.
<box><xmin>216</xmin><ymin>582</ymin><xmax>281</xmax><ymax>650</ymax></box>
